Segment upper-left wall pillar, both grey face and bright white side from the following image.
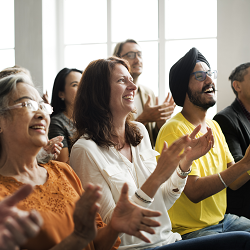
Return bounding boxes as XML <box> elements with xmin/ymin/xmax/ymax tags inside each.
<box><xmin>15</xmin><ymin>0</ymin><xmax>62</xmax><ymax>96</ymax></box>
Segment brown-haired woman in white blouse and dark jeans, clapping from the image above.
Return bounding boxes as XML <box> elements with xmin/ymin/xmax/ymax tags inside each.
<box><xmin>70</xmin><ymin>57</ymin><xmax>250</xmax><ymax>250</ymax></box>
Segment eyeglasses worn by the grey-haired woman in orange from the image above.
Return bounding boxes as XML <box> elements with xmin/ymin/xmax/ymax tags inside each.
<box><xmin>3</xmin><ymin>100</ymin><xmax>53</xmax><ymax>115</ymax></box>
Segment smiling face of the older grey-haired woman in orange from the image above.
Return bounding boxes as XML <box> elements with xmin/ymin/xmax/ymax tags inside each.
<box><xmin>1</xmin><ymin>82</ymin><xmax>50</xmax><ymax>148</ymax></box>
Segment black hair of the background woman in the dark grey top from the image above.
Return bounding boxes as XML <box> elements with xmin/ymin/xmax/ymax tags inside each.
<box><xmin>51</xmin><ymin>68</ymin><xmax>82</xmax><ymax>117</ymax></box>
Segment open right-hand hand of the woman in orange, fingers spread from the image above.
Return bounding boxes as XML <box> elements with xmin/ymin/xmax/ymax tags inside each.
<box><xmin>110</xmin><ymin>183</ymin><xmax>161</xmax><ymax>243</ymax></box>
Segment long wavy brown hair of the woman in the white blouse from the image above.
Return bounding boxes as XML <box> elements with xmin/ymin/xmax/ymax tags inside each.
<box><xmin>73</xmin><ymin>57</ymin><xmax>143</xmax><ymax>148</ymax></box>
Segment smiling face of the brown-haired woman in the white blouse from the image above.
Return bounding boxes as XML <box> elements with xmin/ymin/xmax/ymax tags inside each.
<box><xmin>109</xmin><ymin>64</ymin><xmax>137</xmax><ymax>117</ymax></box>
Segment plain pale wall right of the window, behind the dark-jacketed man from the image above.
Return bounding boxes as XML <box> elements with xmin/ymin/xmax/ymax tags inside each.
<box><xmin>217</xmin><ymin>0</ymin><xmax>250</xmax><ymax>111</ymax></box>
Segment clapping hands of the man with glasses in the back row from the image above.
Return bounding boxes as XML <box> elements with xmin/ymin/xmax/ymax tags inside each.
<box><xmin>136</xmin><ymin>94</ymin><xmax>175</xmax><ymax>128</ymax></box>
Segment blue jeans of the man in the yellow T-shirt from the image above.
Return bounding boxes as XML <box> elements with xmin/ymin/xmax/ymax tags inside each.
<box><xmin>181</xmin><ymin>214</ymin><xmax>250</xmax><ymax>240</ymax></box>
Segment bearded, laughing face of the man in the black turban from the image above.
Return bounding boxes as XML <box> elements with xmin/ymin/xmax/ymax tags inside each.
<box><xmin>186</xmin><ymin>62</ymin><xmax>216</xmax><ymax>111</ymax></box>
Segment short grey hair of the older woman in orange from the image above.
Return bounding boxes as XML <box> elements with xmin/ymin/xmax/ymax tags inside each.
<box><xmin>0</xmin><ymin>74</ymin><xmax>34</xmax><ymax>116</ymax></box>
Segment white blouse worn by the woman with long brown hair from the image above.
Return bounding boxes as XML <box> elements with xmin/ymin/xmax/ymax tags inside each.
<box><xmin>70</xmin><ymin>122</ymin><xmax>187</xmax><ymax>249</ymax></box>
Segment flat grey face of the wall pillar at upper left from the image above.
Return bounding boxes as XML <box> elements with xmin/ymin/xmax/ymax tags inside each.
<box><xmin>15</xmin><ymin>0</ymin><xmax>43</xmax><ymax>86</ymax></box>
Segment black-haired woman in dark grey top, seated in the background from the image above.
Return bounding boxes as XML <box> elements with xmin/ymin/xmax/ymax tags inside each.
<box><xmin>49</xmin><ymin>68</ymin><xmax>82</xmax><ymax>163</ymax></box>
